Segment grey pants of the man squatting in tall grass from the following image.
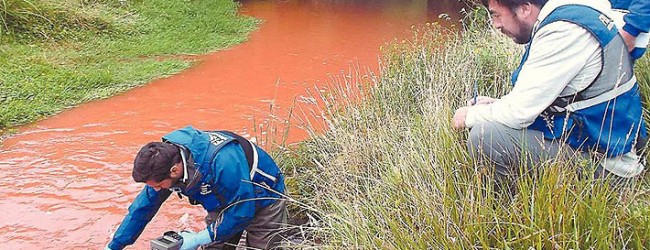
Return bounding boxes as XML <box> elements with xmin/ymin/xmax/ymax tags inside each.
<box><xmin>467</xmin><ymin>122</ymin><xmax>634</xmax><ymax>192</ymax></box>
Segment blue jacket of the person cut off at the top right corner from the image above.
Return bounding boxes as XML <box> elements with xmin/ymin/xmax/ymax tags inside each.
<box><xmin>610</xmin><ymin>0</ymin><xmax>650</xmax><ymax>58</ymax></box>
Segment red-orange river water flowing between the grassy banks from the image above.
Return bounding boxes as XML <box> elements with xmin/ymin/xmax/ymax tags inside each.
<box><xmin>0</xmin><ymin>0</ymin><xmax>460</xmax><ymax>249</ymax></box>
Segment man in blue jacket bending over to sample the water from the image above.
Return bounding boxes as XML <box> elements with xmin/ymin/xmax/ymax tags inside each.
<box><xmin>106</xmin><ymin>126</ymin><xmax>287</xmax><ymax>250</ymax></box>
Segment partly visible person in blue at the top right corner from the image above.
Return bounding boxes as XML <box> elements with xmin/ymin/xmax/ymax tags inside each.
<box><xmin>610</xmin><ymin>0</ymin><xmax>650</xmax><ymax>59</ymax></box>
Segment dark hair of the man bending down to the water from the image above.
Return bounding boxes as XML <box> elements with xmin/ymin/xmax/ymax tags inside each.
<box><xmin>132</xmin><ymin>142</ymin><xmax>181</xmax><ymax>182</ymax></box>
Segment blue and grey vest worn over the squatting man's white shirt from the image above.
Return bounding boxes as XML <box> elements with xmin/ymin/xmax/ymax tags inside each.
<box><xmin>512</xmin><ymin>4</ymin><xmax>646</xmax><ymax>157</ymax></box>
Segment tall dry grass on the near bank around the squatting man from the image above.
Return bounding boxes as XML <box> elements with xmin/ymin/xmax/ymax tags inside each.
<box><xmin>281</xmin><ymin>11</ymin><xmax>650</xmax><ymax>249</ymax></box>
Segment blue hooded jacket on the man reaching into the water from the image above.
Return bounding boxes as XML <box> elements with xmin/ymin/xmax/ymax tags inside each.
<box><xmin>108</xmin><ymin>126</ymin><xmax>285</xmax><ymax>249</ymax></box>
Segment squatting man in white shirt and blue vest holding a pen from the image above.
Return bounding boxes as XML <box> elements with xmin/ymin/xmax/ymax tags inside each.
<box><xmin>453</xmin><ymin>0</ymin><xmax>646</xmax><ymax>189</ymax></box>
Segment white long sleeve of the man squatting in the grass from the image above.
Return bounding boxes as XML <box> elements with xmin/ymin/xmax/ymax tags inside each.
<box><xmin>465</xmin><ymin>21</ymin><xmax>601</xmax><ymax>129</ymax></box>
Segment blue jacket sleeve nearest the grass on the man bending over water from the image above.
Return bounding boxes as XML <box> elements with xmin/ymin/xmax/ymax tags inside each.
<box><xmin>208</xmin><ymin>143</ymin><xmax>255</xmax><ymax>242</ymax></box>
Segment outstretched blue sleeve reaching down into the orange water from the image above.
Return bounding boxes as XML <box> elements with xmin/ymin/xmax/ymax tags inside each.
<box><xmin>108</xmin><ymin>186</ymin><xmax>171</xmax><ymax>250</ymax></box>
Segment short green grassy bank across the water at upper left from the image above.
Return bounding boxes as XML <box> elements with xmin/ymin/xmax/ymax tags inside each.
<box><xmin>0</xmin><ymin>0</ymin><xmax>257</xmax><ymax>131</ymax></box>
